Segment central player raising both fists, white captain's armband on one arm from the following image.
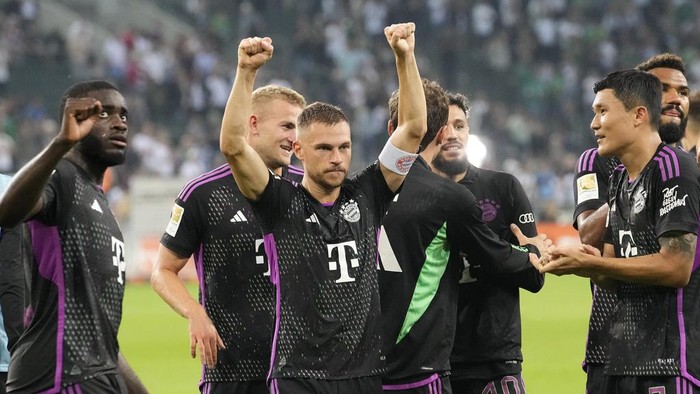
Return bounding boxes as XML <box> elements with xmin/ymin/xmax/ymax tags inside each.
<box><xmin>220</xmin><ymin>23</ymin><xmax>427</xmax><ymax>393</ymax></box>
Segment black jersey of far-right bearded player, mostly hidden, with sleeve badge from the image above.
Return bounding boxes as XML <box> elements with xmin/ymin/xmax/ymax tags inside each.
<box><xmin>574</xmin><ymin>148</ymin><xmax>620</xmax><ymax>365</ymax></box>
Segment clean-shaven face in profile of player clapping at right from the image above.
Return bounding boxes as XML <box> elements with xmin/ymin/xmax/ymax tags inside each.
<box><xmin>591</xmin><ymin>89</ymin><xmax>637</xmax><ymax>157</ymax></box>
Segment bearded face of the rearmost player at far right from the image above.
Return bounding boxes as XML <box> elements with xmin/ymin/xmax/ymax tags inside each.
<box><xmin>649</xmin><ymin>67</ymin><xmax>690</xmax><ymax>144</ymax></box>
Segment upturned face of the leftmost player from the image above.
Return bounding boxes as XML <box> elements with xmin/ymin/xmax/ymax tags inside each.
<box><xmin>77</xmin><ymin>89</ymin><xmax>128</xmax><ymax>167</ymax></box>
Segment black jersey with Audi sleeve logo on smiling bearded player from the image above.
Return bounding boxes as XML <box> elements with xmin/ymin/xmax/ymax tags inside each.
<box><xmin>450</xmin><ymin>165</ymin><xmax>544</xmax><ymax>379</ymax></box>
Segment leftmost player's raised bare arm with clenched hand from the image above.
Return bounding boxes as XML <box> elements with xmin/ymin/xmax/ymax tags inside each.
<box><xmin>0</xmin><ymin>97</ymin><xmax>102</xmax><ymax>228</ymax></box>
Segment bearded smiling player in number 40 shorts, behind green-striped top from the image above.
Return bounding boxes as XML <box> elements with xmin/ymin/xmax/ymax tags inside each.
<box><xmin>432</xmin><ymin>93</ymin><xmax>544</xmax><ymax>394</ymax></box>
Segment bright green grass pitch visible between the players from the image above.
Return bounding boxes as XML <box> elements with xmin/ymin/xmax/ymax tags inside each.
<box><xmin>119</xmin><ymin>275</ymin><xmax>591</xmax><ymax>394</ymax></box>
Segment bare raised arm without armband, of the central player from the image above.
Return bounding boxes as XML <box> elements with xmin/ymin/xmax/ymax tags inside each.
<box><xmin>219</xmin><ymin>37</ymin><xmax>273</xmax><ymax>200</ymax></box>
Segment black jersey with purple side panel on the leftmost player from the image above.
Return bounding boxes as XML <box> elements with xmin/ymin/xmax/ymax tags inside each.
<box><xmin>7</xmin><ymin>159</ymin><xmax>126</xmax><ymax>392</ymax></box>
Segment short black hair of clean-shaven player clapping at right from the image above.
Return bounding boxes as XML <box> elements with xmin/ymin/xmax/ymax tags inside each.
<box><xmin>593</xmin><ymin>69</ymin><xmax>663</xmax><ymax>128</ymax></box>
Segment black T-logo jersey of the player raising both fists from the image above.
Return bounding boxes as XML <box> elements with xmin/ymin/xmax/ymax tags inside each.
<box><xmin>252</xmin><ymin>163</ymin><xmax>394</xmax><ymax>380</ymax></box>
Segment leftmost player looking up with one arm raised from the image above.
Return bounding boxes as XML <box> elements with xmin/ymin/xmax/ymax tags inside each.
<box><xmin>0</xmin><ymin>81</ymin><xmax>146</xmax><ymax>393</ymax></box>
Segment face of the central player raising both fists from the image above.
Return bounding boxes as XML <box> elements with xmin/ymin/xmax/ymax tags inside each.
<box><xmin>294</xmin><ymin>122</ymin><xmax>352</xmax><ymax>191</ymax></box>
